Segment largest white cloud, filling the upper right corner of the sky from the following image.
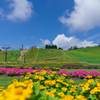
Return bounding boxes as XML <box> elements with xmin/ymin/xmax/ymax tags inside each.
<box><xmin>59</xmin><ymin>0</ymin><xmax>100</xmax><ymax>32</ymax></box>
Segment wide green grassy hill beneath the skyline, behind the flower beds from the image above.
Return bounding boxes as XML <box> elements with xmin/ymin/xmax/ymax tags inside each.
<box><xmin>0</xmin><ymin>46</ymin><xmax>100</xmax><ymax>64</ymax></box>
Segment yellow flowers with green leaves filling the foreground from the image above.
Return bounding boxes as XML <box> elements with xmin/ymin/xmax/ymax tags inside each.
<box><xmin>0</xmin><ymin>70</ymin><xmax>100</xmax><ymax>100</ymax></box>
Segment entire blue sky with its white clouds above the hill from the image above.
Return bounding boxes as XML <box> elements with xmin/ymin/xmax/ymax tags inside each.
<box><xmin>0</xmin><ymin>0</ymin><xmax>100</xmax><ymax>50</ymax></box>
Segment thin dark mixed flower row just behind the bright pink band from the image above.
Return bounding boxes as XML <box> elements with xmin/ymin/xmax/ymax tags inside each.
<box><xmin>0</xmin><ymin>65</ymin><xmax>100</xmax><ymax>71</ymax></box>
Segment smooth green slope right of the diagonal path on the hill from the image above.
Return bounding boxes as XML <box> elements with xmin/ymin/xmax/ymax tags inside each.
<box><xmin>64</xmin><ymin>46</ymin><xmax>100</xmax><ymax>63</ymax></box>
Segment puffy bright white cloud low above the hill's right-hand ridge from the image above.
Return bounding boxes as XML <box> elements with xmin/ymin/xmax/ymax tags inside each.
<box><xmin>53</xmin><ymin>34</ymin><xmax>98</xmax><ymax>50</ymax></box>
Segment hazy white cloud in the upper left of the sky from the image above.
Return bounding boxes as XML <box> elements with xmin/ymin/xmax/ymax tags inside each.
<box><xmin>7</xmin><ymin>0</ymin><xmax>33</xmax><ymax>21</ymax></box>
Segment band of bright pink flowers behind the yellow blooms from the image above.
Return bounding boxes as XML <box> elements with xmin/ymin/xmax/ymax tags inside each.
<box><xmin>0</xmin><ymin>68</ymin><xmax>100</xmax><ymax>78</ymax></box>
